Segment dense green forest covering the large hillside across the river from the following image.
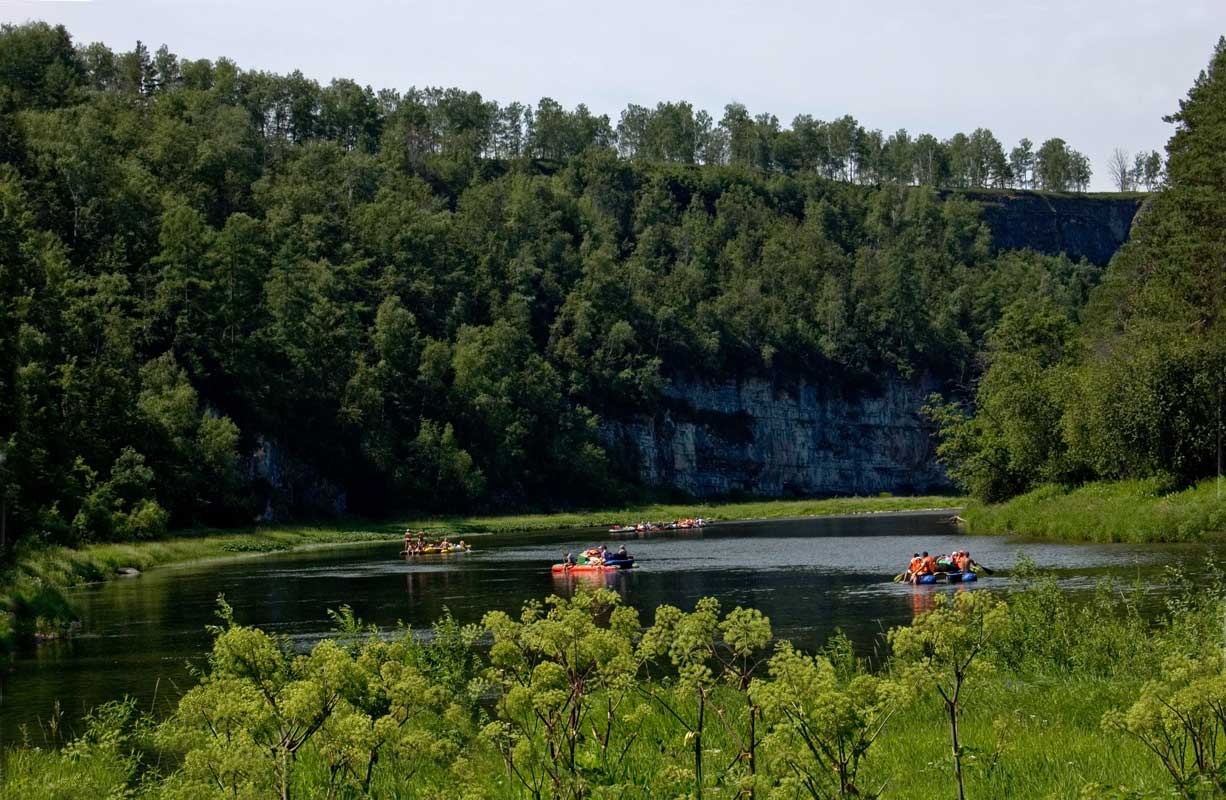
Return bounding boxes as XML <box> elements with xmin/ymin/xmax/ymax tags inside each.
<box><xmin>0</xmin><ymin>23</ymin><xmax>1123</xmax><ymax>543</ymax></box>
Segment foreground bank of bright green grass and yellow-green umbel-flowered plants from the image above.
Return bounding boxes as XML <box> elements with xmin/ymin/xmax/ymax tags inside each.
<box><xmin>2</xmin><ymin>564</ymin><xmax>1226</xmax><ymax>800</ymax></box>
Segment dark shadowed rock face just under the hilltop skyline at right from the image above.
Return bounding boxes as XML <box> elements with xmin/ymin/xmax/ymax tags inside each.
<box><xmin>964</xmin><ymin>191</ymin><xmax>1144</xmax><ymax>266</ymax></box>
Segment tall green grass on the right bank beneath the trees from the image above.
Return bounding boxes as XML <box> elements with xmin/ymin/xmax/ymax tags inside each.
<box><xmin>961</xmin><ymin>479</ymin><xmax>1226</xmax><ymax>542</ymax></box>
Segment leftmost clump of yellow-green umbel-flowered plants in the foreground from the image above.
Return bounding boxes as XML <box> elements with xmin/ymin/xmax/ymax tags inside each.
<box><xmin>158</xmin><ymin>600</ymin><xmax>468</xmax><ymax>799</ymax></box>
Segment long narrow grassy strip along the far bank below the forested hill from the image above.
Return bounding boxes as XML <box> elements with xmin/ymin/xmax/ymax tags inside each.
<box><xmin>0</xmin><ymin>496</ymin><xmax>962</xmax><ymax>653</ymax></box>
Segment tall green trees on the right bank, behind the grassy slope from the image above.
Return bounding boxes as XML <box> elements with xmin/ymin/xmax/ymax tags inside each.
<box><xmin>934</xmin><ymin>38</ymin><xmax>1226</xmax><ymax>500</ymax></box>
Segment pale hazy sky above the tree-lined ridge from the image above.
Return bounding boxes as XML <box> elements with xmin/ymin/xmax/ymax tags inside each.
<box><xmin>0</xmin><ymin>0</ymin><xmax>1226</xmax><ymax>190</ymax></box>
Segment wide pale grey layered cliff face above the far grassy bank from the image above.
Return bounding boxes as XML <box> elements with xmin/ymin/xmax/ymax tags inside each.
<box><xmin>601</xmin><ymin>377</ymin><xmax>949</xmax><ymax>497</ymax></box>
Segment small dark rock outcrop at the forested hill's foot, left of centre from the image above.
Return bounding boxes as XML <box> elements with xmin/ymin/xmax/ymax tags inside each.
<box><xmin>244</xmin><ymin>436</ymin><xmax>348</xmax><ymax>522</ymax></box>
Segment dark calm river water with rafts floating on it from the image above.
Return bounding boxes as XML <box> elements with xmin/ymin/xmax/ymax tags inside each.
<box><xmin>0</xmin><ymin>513</ymin><xmax>1204</xmax><ymax>745</ymax></box>
